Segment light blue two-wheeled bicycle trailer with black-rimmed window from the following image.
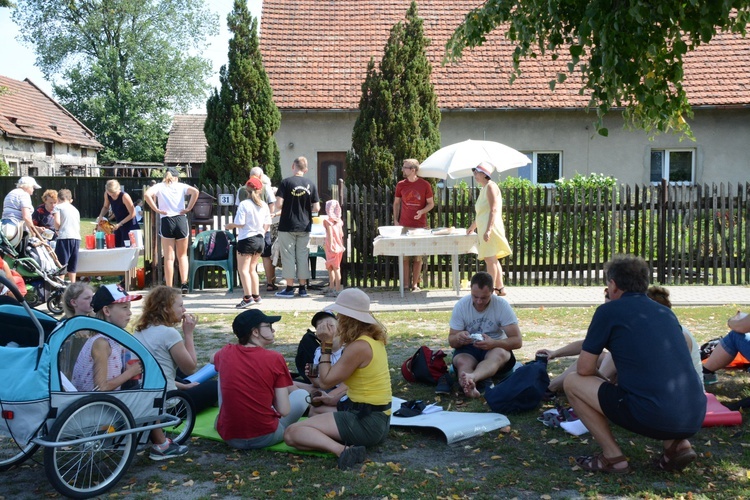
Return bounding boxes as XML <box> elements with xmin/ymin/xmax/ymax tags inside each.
<box><xmin>0</xmin><ymin>273</ymin><xmax>192</xmax><ymax>498</ymax></box>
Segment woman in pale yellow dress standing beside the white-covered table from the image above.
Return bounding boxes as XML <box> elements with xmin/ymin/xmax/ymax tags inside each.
<box><xmin>466</xmin><ymin>162</ymin><xmax>513</xmax><ymax>295</ymax></box>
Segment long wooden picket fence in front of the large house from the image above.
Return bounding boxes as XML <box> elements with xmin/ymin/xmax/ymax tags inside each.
<box><xmin>135</xmin><ymin>181</ymin><xmax>750</xmax><ymax>288</ymax></box>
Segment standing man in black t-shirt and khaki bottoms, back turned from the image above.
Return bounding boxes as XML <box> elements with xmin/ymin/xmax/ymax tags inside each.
<box><xmin>276</xmin><ymin>156</ymin><xmax>320</xmax><ymax>298</ymax></box>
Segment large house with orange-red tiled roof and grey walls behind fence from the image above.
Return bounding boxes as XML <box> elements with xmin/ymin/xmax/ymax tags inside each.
<box><xmin>260</xmin><ymin>0</ymin><xmax>750</xmax><ymax>195</ymax></box>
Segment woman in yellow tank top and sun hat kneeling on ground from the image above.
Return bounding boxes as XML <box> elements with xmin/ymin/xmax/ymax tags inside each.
<box><xmin>284</xmin><ymin>288</ymin><xmax>392</xmax><ymax>469</ymax></box>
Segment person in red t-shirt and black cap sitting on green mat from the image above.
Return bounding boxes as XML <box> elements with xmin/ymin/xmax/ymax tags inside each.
<box><xmin>211</xmin><ymin>309</ymin><xmax>307</xmax><ymax>450</ymax></box>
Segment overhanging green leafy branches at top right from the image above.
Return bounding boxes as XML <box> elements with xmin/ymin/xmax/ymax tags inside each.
<box><xmin>446</xmin><ymin>0</ymin><xmax>750</xmax><ymax>136</ymax></box>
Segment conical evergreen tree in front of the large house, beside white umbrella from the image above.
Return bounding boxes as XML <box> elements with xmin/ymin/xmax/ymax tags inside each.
<box><xmin>347</xmin><ymin>2</ymin><xmax>440</xmax><ymax>187</ymax></box>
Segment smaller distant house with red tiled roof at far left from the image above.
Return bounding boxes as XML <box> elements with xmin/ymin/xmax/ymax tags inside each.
<box><xmin>0</xmin><ymin>76</ymin><xmax>104</xmax><ymax>176</ymax></box>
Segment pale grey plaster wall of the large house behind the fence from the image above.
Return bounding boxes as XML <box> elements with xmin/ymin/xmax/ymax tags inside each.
<box><xmin>276</xmin><ymin>109</ymin><xmax>750</xmax><ymax>184</ymax></box>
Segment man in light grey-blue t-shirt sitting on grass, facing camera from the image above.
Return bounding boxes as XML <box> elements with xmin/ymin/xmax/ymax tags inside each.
<box><xmin>448</xmin><ymin>272</ymin><xmax>522</xmax><ymax>398</ymax></box>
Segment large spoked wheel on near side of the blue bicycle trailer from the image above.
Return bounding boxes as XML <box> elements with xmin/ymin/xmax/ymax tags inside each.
<box><xmin>44</xmin><ymin>395</ymin><xmax>138</xmax><ymax>498</ymax></box>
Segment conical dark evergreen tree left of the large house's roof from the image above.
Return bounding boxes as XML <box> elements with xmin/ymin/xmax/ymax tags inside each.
<box><xmin>201</xmin><ymin>0</ymin><xmax>281</xmax><ymax>184</ymax></box>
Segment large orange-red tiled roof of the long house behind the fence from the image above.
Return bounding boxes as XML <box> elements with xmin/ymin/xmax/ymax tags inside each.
<box><xmin>260</xmin><ymin>0</ymin><xmax>750</xmax><ymax>110</ymax></box>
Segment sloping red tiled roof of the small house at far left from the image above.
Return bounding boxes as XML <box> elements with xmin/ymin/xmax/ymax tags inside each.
<box><xmin>0</xmin><ymin>76</ymin><xmax>104</xmax><ymax>149</ymax></box>
